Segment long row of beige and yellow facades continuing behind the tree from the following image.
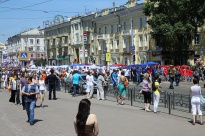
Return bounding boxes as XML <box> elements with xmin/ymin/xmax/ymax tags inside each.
<box><xmin>44</xmin><ymin>0</ymin><xmax>205</xmax><ymax>65</ymax></box>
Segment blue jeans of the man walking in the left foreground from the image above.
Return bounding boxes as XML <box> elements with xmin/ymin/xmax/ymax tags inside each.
<box><xmin>25</xmin><ymin>100</ymin><xmax>36</xmax><ymax>123</ymax></box>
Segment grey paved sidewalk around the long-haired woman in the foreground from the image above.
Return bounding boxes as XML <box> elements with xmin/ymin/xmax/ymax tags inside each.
<box><xmin>0</xmin><ymin>89</ymin><xmax>205</xmax><ymax>136</ymax></box>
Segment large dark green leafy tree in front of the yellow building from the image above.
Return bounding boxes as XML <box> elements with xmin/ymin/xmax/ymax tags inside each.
<box><xmin>143</xmin><ymin>0</ymin><xmax>205</xmax><ymax>64</ymax></box>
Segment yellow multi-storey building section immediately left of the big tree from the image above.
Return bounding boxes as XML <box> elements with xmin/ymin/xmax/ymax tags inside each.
<box><xmin>94</xmin><ymin>0</ymin><xmax>149</xmax><ymax>64</ymax></box>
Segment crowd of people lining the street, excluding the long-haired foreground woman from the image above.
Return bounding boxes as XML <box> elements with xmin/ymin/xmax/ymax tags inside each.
<box><xmin>2</xmin><ymin>65</ymin><xmax>205</xmax><ymax>133</ymax></box>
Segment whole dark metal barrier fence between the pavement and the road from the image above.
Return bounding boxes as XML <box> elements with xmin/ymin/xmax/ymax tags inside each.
<box><xmin>61</xmin><ymin>82</ymin><xmax>205</xmax><ymax>117</ymax></box>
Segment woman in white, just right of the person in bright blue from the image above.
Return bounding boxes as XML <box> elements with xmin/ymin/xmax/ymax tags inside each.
<box><xmin>86</xmin><ymin>71</ymin><xmax>97</xmax><ymax>98</ymax></box>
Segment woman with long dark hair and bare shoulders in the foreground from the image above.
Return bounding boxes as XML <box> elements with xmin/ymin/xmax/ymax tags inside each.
<box><xmin>74</xmin><ymin>99</ymin><xmax>99</xmax><ymax>136</ymax></box>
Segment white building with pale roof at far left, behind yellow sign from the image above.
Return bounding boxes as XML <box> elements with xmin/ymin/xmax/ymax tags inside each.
<box><xmin>8</xmin><ymin>28</ymin><xmax>46</xmax><ymax>64</ymax></box>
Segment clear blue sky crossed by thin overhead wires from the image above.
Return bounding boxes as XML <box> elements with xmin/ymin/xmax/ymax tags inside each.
<box><xmin>0</xmin><ymin>0</ymin><xmax>142</xmax><ymax>43</ymax></box>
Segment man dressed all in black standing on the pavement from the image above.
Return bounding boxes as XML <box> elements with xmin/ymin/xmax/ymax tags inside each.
<box><xmin>45</xmin><ymin>69</ymin><xmax>58</xmax><ymax>100</ymax></box>
